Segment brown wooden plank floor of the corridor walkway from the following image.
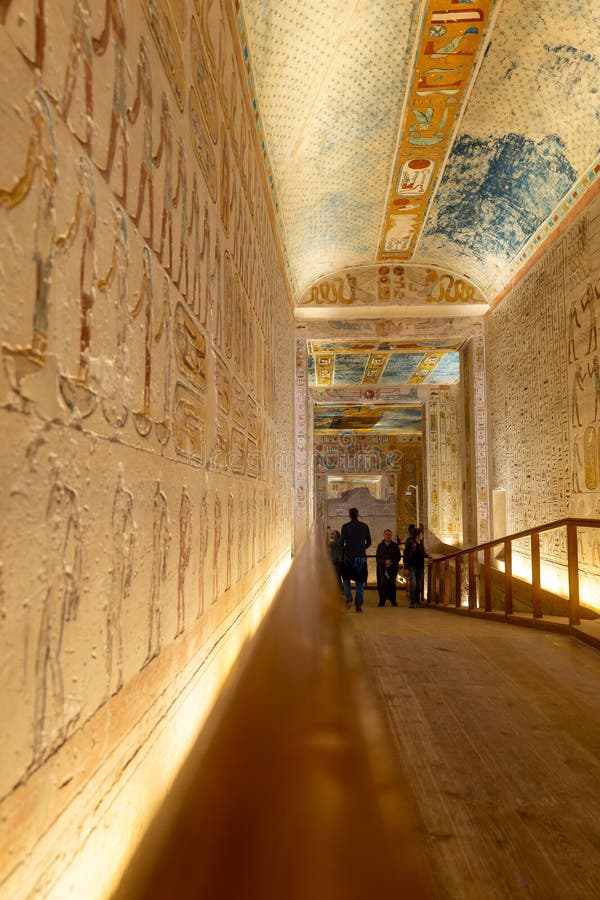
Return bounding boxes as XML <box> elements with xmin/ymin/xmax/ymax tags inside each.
<box><xmin>344</xmin><ymin>591</ymin><xmax>600</xmax><ymax>900</ymax></box>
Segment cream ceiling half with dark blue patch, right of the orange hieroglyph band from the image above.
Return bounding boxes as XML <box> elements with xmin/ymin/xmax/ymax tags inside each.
<box><xmin>414</xmin><ymin>0</ymin><xmax>600</xmax><ymax>295</ymax></box>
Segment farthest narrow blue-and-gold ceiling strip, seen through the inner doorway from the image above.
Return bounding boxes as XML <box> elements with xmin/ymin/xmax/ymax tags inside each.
<box><xmin>314</xmin><ymin>403</ymin><xmax>422</xmax><ymax>436</ymax></box>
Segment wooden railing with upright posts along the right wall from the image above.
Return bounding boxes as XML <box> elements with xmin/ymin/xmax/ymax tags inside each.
<box><xmin>427</xmin><ymin>518</ymin><xmax>600</xmax><ymax>628</ymax></box>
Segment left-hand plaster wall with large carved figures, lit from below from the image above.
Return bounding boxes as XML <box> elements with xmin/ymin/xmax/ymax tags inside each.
<box><xmin>0</xmin><ymin>0</ymin><xmax>294</xmax><ymax>898</ymax></box>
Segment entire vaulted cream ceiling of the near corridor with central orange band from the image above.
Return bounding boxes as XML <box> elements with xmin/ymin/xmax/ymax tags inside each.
<box><xmin>234</xmin><ymin>0</ymin><xmax>600</xmax><ymax>304</ymax></box>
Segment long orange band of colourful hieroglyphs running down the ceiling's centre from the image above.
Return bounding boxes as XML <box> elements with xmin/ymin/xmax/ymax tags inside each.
<box><xmin>378</xmin><ymin>0</ymin><xmax>496</xmax><ymax>261</ymax></box>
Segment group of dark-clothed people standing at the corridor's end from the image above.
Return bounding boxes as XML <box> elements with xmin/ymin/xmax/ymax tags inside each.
<box><xmin>329</xmin><ymin>507</ymin><xmax>429</xmax><ymax>612</ymax></box>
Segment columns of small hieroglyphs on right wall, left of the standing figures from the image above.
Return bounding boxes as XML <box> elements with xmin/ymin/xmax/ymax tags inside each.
<box><xmin>486</xmin><ymin>214</ymin><xmax>568</xmax><ymax>556</ymax></box>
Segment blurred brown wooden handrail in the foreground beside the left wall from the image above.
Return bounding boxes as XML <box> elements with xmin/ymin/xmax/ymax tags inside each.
<box><xmin>115</xmin><ymin>528</ymin><xmax>432</xmax><ymax>900</ymax></box>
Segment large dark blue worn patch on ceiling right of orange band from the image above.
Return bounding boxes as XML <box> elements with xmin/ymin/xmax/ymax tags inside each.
<box><xmin>427</xmin><ymin>134</ymin><xmax>577</xmax><ymax>261</ymax></box>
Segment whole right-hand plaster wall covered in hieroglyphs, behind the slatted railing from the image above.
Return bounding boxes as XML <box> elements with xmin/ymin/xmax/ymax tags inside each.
<box><xmin>485</xmin><ymin>191</ymin><xmax>600</xmax><ymax>570</ymax></box>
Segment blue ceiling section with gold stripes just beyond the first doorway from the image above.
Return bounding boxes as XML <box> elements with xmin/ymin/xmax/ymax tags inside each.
<box><xmin>307</xmin><ymin>340</ymin><xmax>462</xmax><ymax>387</ymax></box>
